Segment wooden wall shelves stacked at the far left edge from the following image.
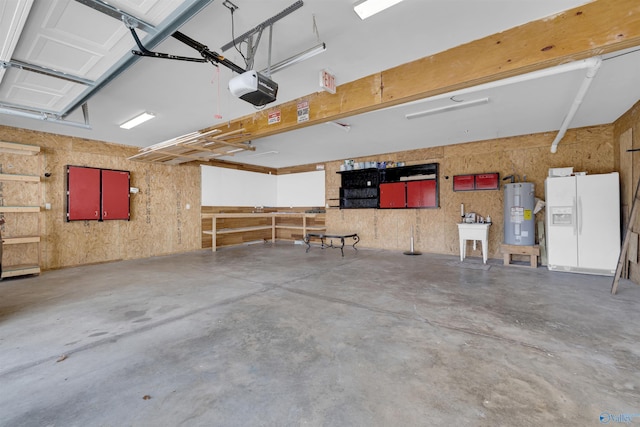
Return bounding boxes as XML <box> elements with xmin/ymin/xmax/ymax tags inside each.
<box><xmin>0</xmin><ymin>141</ymin><xmax>41</xmax><ymax>278</ymax></box>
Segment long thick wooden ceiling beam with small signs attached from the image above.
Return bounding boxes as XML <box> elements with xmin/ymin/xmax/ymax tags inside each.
<box><xmin>202</xmin><ymin>0</ymin><xmax>640</xmax><ymax>143</ymax></box>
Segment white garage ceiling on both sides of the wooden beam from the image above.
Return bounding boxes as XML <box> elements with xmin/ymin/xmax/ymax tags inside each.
<box><xmin>0</xmin><ymin>0</ymin><xmax>640</xmax><ymax>167</ymax></box>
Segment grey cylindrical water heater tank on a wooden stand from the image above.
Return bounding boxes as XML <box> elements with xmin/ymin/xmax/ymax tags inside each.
<box><xmin>504</xmin><ymin>182</ymin><xmax>535</xmax><ymax>246</ymax></box>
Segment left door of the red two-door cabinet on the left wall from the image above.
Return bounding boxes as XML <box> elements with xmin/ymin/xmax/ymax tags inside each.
<box><xmin>67</xmin><ymin>166</ymin><xmax>100</xmax><ymax>221</ymax></box>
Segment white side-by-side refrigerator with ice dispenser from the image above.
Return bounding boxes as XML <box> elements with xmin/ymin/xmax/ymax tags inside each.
<box><xmin>545</xmin><ymin>172</ymin><xmax>620</xmax><ymax>276</ymax></box>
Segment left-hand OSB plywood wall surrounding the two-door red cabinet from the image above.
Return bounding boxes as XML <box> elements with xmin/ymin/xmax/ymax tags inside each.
<box><xmin>0</xmin><ymin>127</ymin><xmax>200</xmax><ymax>270</ymax></box>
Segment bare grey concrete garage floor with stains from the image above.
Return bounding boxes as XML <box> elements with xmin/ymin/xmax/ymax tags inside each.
<box><xmin>0</xmin><ymin>243</ymin><xmax>640</xmax><ymax>426</ymax></box>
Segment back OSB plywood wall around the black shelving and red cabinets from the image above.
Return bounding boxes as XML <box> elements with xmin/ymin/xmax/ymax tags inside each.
<box><xmin>326</xmin><ymin>125</ymin><xmax>617</xmax><ymax>258</ymax></box>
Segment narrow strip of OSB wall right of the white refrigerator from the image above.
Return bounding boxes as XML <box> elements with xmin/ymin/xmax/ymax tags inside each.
<box><xmin>613</xmin><ymin>102</ymin><xmax>640</xmax><ymax>283</ymax></box>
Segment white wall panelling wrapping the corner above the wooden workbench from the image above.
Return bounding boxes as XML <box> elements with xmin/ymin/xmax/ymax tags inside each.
<box><xmin>200</xmin><ymin>165</ymin><xmax>325</xmax><ymax>207</ymax></box>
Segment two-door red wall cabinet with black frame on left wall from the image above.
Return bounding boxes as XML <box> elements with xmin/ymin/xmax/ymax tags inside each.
<box><xmin>67</xmin><ymin>166</ymin><xmax>130</xmax><ymax>221</ymax></box>
